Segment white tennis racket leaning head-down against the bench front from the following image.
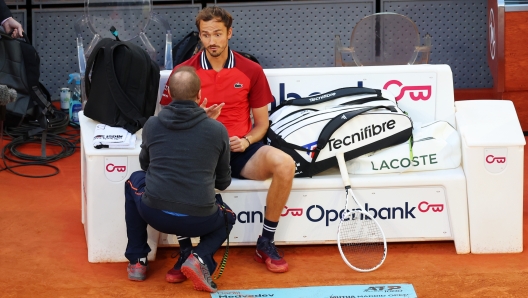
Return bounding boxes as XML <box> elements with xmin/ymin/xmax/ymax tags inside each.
<box><xmin>336</xmin><ymin>153</ymin><xmax>387</xmax><ymax>272</ymax></box>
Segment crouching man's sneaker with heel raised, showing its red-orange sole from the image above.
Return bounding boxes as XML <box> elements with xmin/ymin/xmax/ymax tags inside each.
<box><xmin>181</xmin><ymin>253</ymin><xmax>217</xmax><ymax>293</ymax></box>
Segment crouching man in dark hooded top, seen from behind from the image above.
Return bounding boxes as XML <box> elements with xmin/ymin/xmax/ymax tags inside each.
<box><xmin>125</xmin><ymin>67</ymin><xmax>235</xmax><ymax>292</ymax></box>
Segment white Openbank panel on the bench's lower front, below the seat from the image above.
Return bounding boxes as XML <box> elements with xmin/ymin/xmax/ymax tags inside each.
<box><xmin>222</xmin><ymin>187</ymin><xmax>452</xmax><ymax>243</ymax></box>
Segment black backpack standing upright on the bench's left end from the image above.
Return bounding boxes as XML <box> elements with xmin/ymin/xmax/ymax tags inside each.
<box><xmin>84</xmin><ymin>38</ymin><xmax>160</xmax><ymax>133</ymax></box>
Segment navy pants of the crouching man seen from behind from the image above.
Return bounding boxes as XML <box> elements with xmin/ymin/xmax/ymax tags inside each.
<box><xmin>125</xmin><ymin>171</ymin><xmax>235</xmax><ymax>274</ymax></box>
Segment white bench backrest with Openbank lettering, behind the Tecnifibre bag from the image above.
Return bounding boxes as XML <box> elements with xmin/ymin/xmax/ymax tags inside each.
<box><xmin>264</xmin><ymin>65</ymin><xmax>454</xmax><ymax>125</ymax></box>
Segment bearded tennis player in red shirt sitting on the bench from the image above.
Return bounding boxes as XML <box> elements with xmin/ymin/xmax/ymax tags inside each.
<box><xmin>161</xmin><ymin>6</ymin><xmax>295</xmax><ymax>272</ymax></box>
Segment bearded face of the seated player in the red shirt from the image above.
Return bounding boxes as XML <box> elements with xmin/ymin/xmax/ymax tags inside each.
<box><xmin>200</xmin><ymin>20</ymin><xmax>233</xmax><ymax>57</ymax></box>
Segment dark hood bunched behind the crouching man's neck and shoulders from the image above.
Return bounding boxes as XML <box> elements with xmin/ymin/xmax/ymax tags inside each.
<box><xmin>158</xmin><ymin>100</ymin><xmax>207</xmax><ymax>130</ymax></box>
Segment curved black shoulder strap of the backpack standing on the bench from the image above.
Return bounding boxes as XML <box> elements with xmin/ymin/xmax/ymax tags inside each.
<box><xmin>104</xmin><ymin>42</ymin><xmax>150</xmax><ymax>133</ymax></box>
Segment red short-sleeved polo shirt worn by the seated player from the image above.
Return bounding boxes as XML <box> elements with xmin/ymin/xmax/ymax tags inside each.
<box><xmin>160</xmin><ymin>50</ymin><xmax>274</xmax><ymax>137</ymax></box>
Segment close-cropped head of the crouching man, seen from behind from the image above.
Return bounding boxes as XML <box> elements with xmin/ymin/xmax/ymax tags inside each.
<box><xmin>169</xmin><ymin>66</ymin><xmax>201</xmax><ymax>101</ymax></box>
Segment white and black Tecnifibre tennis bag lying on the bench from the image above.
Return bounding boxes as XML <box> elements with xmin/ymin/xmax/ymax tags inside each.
<box><xmin>267</xmin><ymin>87</ymin><xmax>413</xmax><ymax>177</ymax></box>
